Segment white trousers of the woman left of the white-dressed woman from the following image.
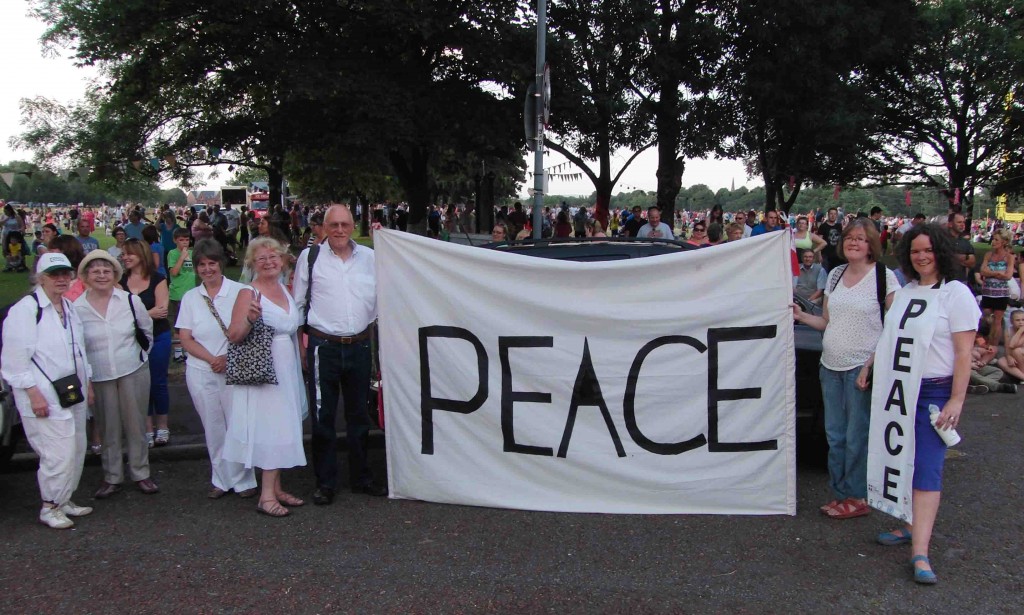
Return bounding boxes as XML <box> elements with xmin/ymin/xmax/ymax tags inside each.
<box><xmin>185</xmin><ymin>365</ymin><xmax>256</xmax><ymax>492</ymax></box>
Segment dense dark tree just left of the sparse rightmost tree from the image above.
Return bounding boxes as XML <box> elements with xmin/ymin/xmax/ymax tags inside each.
<box><xmin>721</xmin><ymin>0</ymin><xmax>914</xmax><ymax>211</ymax></box>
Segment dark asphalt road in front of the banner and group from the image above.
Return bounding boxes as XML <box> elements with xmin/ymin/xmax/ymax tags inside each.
<box><xmin>0</xmin><ymin>392</ymin><xmax>1024</xmax><ymax>613</ymax></box>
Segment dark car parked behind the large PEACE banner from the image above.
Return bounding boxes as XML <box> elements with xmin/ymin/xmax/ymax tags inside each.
<box><xmin>481</xmin><ymin>237</ymin><xmax>824</xmax><ymax>438</ymax></box>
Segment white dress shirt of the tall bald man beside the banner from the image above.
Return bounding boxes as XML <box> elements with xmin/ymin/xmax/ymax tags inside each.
<box><xmin>292</xmin><ymin>239</ymin><xmax>377</xmax><ymax>336</ymax></box>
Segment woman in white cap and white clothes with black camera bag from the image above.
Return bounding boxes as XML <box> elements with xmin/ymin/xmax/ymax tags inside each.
<box><xmin>0</xmin><ymin>252</ymin><xmax>93</xmax><ymax>529</ymax></box>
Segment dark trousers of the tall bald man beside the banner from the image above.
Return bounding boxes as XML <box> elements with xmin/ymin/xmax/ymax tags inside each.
<box><xmin>306</xmin><ymin>336</ymin><xmax>373</xmax><ymax>489</ymax></box>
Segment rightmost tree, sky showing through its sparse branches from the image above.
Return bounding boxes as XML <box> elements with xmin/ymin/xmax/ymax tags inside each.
<box><xmin>878</xmin><ymin>0</ymin><xmax>1024</xmax><ymax>217</ymax></box>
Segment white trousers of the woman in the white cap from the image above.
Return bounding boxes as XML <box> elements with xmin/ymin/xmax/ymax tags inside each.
<box><xmin>22</xmin><ymin>403</ymin><xmax>86</xmax><ymax>506</ymax></box>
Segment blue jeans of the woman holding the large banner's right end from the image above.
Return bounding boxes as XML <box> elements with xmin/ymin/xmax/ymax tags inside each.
<box><xmin>818</xmin><ymin>365</ymin><xmax>871</xmax><ymax>500</ymax></box>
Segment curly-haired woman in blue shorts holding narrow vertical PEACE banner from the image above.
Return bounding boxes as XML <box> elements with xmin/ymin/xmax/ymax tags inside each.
<box><xmin>857</xmin><ymin>224</ymin><xmax>981</xmax><ymax>584</ymax></box>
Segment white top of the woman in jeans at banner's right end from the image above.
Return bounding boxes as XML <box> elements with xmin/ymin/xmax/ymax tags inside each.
<box><xmin>821</xmin><ymin>266</ymin><xmax>899</xmax><ymax>371</ymax></box>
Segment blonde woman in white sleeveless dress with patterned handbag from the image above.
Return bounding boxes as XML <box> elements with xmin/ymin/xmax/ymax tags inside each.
<box><xmin>223</xmin><ymin>237</ymin><xmax>306</xmax><ymax>517</ymax></box>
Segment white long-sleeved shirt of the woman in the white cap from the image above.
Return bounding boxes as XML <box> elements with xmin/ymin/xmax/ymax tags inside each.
<box><xmin>0</xmin><ymin>291</ymin><xmax>91</xmax><ymax>421</ymax></box>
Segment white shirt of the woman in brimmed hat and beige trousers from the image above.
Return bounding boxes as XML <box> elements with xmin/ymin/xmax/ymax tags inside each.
<box><xmin>75</xmin><ymin>289</ymin><xmax>153</xmax><ymax>383</ymax></box>
